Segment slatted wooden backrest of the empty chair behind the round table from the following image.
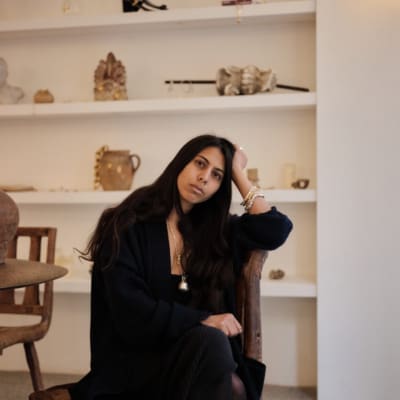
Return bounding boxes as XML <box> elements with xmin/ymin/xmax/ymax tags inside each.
<box><xmin>0</xmin><ymin>227</ymin><xmax>57</xmax><ymax>325</ymax></box>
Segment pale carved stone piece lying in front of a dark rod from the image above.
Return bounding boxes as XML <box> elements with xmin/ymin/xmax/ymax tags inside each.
<box><xmin>216</xmin><ymin>65</ymin><xmax>277</xmax><ymax>96</ymax></box>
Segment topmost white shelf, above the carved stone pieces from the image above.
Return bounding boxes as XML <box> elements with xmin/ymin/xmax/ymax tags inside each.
<box><xmin>0</xmin><ymin>0</ymin><xmax>316</xmax><ymax>37</ymax></box>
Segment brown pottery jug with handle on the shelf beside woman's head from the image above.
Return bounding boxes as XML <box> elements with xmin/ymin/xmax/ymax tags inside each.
<box><xmin>97</xmin><ymin>150</ymin><xmax>141</xmax><ymax>190</ymax></box>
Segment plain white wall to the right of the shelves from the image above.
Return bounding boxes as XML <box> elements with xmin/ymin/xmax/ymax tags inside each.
<box><xmin>317</xmin><ymin>0</ymin><xmax>400</xmax><ymax>400</ymax></box>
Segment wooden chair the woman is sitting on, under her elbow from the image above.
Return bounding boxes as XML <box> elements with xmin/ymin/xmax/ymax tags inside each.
<box><xmin>29</xmin><ymin>250</ymin><xmax>268</xmax><ymax>400</ymax></box>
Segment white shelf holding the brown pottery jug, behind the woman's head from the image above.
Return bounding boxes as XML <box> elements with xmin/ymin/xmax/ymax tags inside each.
<box><xmin>8</xmin><ymin>189</ymin><xmax>316</xmax><ymax>205</ymax></box>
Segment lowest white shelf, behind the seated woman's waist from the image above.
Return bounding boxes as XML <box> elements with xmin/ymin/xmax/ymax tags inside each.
<box><xmin>54</xmin><ymin>275</ymin><xmax>317</xmax><ymax>298</ymax></box>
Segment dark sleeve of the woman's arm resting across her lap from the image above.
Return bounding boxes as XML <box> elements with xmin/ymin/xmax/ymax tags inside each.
<box><xmin>97</xmin><ymin>230</ymin><xmax>209</xmax><ymax>344</ymax></box>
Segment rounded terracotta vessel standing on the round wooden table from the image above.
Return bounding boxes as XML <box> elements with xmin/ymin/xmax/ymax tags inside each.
<box><xmin>0</xmin><ymin>191</ymin><xmax>19</xmax><ymax>264</ymax></box>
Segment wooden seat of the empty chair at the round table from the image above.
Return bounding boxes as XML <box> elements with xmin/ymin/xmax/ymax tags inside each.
<box><xmin>0</xmin><ymin>324</ymin><xmax>47</xmax><ymax>352</ymax></box>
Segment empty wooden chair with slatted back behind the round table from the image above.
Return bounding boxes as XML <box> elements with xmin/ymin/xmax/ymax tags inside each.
<box><xmin>0</xmin><ymin>227</ymin><xmax>57</xmax><ymax>391</ymax></box>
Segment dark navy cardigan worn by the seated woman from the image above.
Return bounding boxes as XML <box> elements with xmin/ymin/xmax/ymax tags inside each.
<box><xmin>71</xmin><ymin>207</ymin><xmax>292</xmax><ymax>400</ymax></box>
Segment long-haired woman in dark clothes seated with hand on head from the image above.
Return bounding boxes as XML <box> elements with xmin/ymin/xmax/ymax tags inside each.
<box><xmin>71</xmin><ymin>135</ymin><xmax>292</xmax><ymax>400</ymax></box>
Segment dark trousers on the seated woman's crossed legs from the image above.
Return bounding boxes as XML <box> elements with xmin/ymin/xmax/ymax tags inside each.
<box><xmin>96</xmin><ymin>325</ymin><xmax>237</xmax><ymax>400</ymax></box>
